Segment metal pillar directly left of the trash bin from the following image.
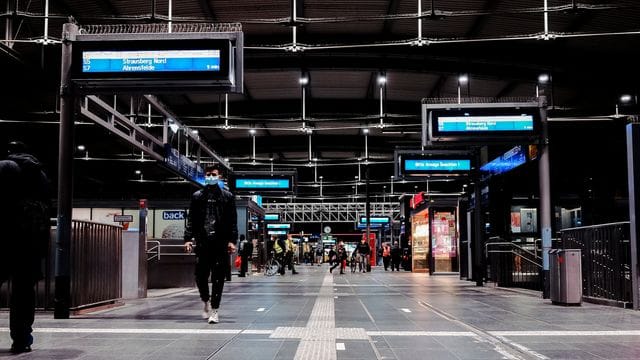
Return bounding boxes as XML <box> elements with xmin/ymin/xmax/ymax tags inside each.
<box><xmin>538</xmin><ymin>95</ymin><xmax>551</xmax><ymax>299</ymax></box>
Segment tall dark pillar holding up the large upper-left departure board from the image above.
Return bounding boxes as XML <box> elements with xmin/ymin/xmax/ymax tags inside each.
<box><xmin>54</xmin><ymin>23</ymin><xmax>78</xmax><ymax>319</ymax></box>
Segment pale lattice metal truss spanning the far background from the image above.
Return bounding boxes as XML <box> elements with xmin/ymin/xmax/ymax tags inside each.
<box><xmin>263</xmin><ymin>202</ymin><xmax>400</xmax><ymax>223</ymax></box>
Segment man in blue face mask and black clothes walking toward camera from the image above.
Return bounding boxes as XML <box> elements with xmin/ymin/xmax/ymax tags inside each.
<box><xmin>184</xmin><ymin>165</ymin><xmax>238</xmax><ymax>324</ymax></box>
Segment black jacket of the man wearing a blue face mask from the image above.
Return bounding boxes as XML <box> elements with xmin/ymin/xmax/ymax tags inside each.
<box><xmin>184</xmin><ymin>185</ymin><xmax>238</xmax><ymax>255</ymax></box>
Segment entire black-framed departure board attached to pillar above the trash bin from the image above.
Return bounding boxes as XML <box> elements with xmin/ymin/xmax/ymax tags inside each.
<box><xmin>422</xmin><ymin>102</ymin><xmax>540</xmax><ymax>146</ymax></box>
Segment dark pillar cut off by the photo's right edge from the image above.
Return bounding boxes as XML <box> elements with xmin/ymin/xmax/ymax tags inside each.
<box><xmin>627</xmin><ymin>124</ymin><xmax>640</xmax><ymax>310</ymax></box>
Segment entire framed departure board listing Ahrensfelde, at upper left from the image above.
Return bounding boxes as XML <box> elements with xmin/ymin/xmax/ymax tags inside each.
<box><xmin>71</xmin><ymin>32</ymin><xmax>243</xmax><ymax>93</ymax></box>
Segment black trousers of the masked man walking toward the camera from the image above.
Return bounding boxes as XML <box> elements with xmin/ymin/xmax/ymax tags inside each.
<box><xmin>196</xmin><ymin>253</ymin><xmax>230</xmax><ymax>309</ymax></box>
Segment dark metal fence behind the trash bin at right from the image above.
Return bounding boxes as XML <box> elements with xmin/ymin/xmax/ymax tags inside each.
<box><xmin>560</xmin><ymin>221</ymin><xmax>633</xmax><ymax>307</ymax></box>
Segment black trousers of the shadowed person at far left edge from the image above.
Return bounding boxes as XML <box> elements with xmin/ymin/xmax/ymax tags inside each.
<box><xmin>0</xmin><ymin>275</ymin><xmax>36</xmax><ymax>347</ymax></box>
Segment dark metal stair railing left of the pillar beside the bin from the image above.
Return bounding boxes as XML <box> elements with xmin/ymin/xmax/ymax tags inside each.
<box><xmin>485</xmin><ymin>237</ymin><xmax>542</xmax><ymax>290</ymax></box>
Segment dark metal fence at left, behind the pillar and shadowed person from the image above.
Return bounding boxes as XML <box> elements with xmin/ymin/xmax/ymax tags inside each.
<box><xmin>0</xmin><ymin>220</ymin><xmax>122</xmax><ymax>310</ymax></box>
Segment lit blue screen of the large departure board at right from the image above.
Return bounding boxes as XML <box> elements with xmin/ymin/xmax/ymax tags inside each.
<box><xmin>438</xmin><ymin>115</ymin><xmax>533</xmax><ymax>133</ymax></box>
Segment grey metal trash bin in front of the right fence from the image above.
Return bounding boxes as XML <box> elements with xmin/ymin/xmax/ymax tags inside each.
<box><xmin>549</xmin><ymin>249</ymin><xmax>582</xmax><ymax>305</ymax></box>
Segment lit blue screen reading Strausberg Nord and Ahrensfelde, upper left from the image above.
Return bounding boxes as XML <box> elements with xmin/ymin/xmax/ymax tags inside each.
<box><xmin>82</xmin><ymin>49</ymin><xmax>220</xmax><ymax>73</ymax></box>
